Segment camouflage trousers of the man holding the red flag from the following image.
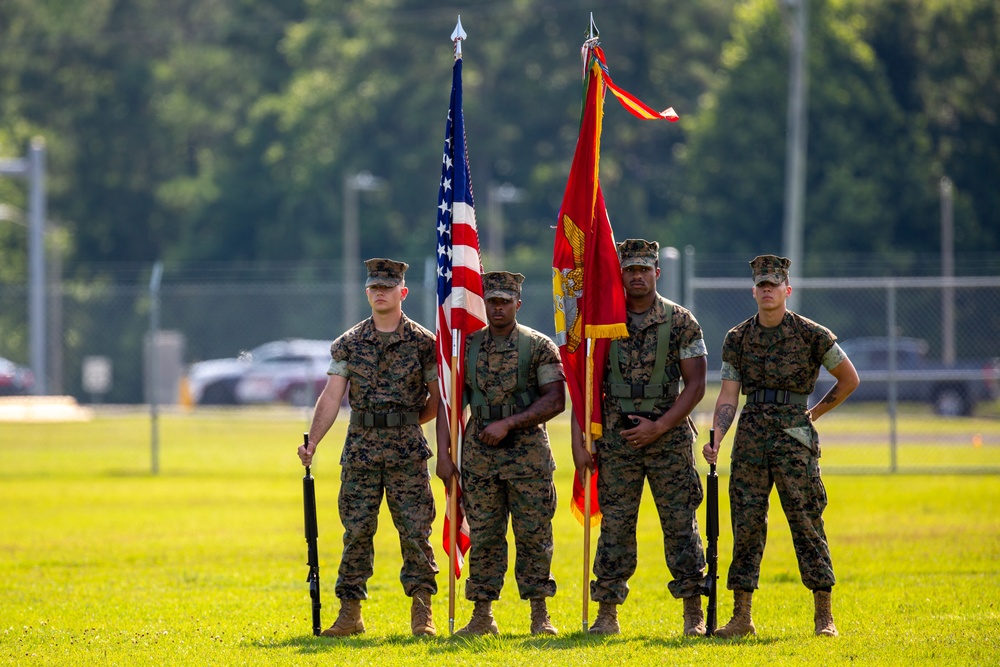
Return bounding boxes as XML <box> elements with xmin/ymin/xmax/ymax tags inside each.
<box><xmin>590</xmin><ymin>436</ymin><xmax>705</xmax><ymax>604</ymax></box>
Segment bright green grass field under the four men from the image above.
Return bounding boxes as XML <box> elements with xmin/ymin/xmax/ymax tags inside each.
<box><xmin>0</xmin><ymin>407</ymin><xmax>1000</xmax><ymax>667</ymax></box>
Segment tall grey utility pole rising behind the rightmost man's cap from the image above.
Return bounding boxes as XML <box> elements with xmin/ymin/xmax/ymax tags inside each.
<box><xmin>781</xmin><ymin>0</ymin><xmax>809</xmax><ymax>310</ymax></box>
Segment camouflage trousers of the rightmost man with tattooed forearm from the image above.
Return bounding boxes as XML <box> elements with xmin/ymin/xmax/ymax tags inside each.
<box><xmin>728</xmin><ymin>410</ymin><xmax>836</xmax><ymax>590</ymax></box>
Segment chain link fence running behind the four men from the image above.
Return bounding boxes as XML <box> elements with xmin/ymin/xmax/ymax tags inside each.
<box><xmin>0</xmin><ymin>249</ymin><xmax>1000</xmax><ymax>470</ymax></box>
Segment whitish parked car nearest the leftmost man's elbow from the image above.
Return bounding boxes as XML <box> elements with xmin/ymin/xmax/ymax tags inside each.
<box><xmin>235</xmin><ymin>340</ymin><xmax>330</xmax><ymax>406</ymax></box>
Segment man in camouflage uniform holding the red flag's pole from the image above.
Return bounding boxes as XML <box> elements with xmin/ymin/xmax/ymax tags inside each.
<box><xmin>577</xmin><ymin>239</ymin><xmax>707</xmax><ymax>635</ymax></box>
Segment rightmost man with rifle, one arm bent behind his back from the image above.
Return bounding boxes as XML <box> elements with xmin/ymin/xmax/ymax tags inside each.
<box><xmin>705</xmin><ymin>255</ymin><xmax>858</xmax><ymax>637</ymax></box>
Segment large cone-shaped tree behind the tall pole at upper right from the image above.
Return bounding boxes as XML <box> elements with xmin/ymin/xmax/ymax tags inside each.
<box><xmin>674</xmin><ymin>0</ymin><xmax>938</xmax><ymax>265</ymax></box>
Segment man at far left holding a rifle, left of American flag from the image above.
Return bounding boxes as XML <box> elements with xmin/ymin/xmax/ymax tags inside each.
<box><xmin>300</xmin><ymin>259</ymin><xmax>438</xmax><ymax>636</ymax></box>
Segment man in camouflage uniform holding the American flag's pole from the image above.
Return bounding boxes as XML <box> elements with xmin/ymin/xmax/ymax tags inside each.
<box><xmin>437</xmin><ymin>271</ymin><xmax>565</xmax><ymax>635</ymax></box>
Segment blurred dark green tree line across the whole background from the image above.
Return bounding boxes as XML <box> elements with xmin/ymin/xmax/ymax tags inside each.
<box><xmin>0</xmin><ymin>0</ymin><xmax>1000</xmax><ymax>283</ymax></box>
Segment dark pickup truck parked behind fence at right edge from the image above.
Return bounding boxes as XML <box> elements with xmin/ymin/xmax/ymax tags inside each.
<box><xmin>813</xmin><ymin>337</ymin><xmax>1000</xmax><ymax>416</ymax></box>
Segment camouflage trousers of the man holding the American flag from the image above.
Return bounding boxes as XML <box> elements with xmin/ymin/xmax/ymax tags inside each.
<box><xmin>462</xmin><ymin>471</ymin><xmax>556</xmax><ymax>602</ymax></box>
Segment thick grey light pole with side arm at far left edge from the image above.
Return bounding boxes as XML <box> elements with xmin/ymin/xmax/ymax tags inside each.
<box><xmin>0</xmin><ymin>137</ymin><xmax>48</xmax><ymax>396</ymax></box>
